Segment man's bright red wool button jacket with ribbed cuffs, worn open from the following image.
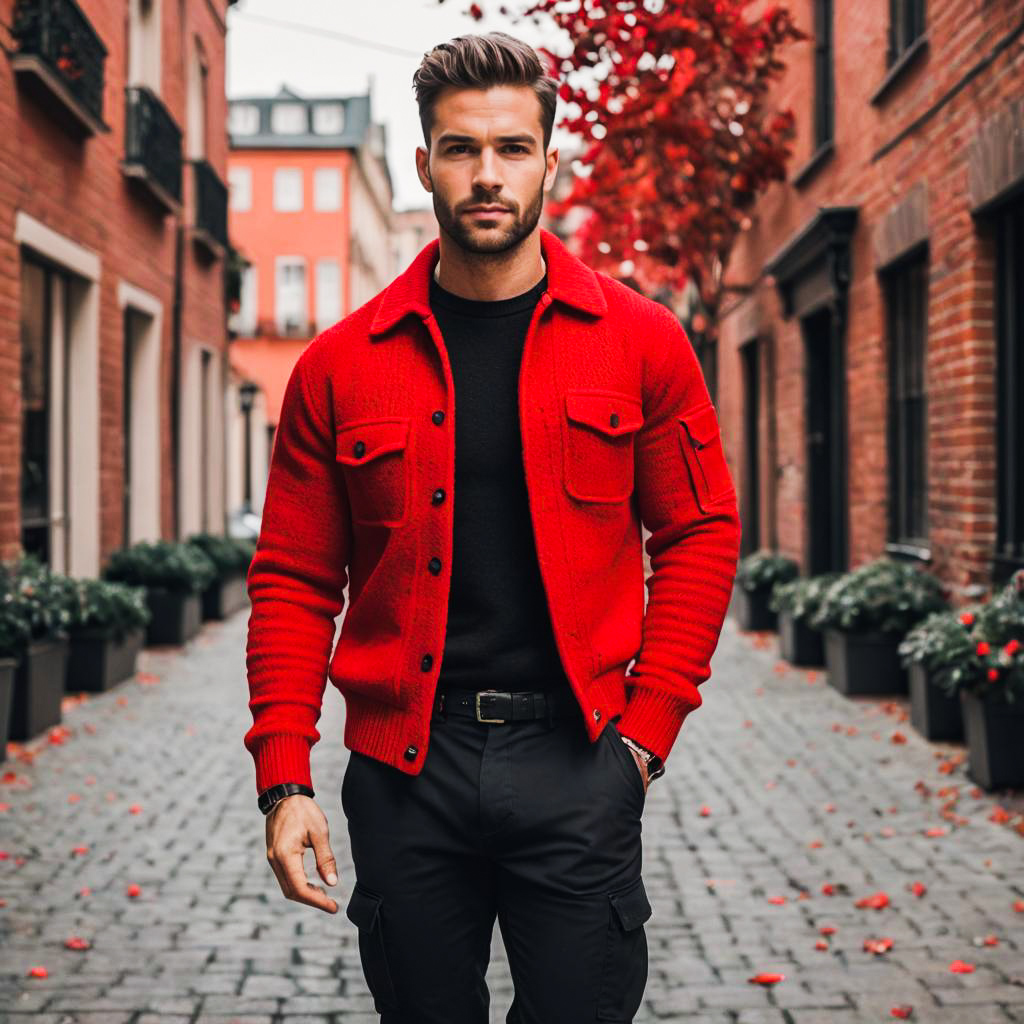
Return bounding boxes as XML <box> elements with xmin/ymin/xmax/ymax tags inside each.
<box><xmin>244</xmin><ymin>228</ymin><xmax>740</xmax><ymax>791</ymax></box>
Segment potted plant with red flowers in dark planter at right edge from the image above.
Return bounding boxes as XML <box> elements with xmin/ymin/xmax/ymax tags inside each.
<box><xmin>950</xmin><ymin>569</ymin><xmax>1024</xmax><ymax>790</ymax></box>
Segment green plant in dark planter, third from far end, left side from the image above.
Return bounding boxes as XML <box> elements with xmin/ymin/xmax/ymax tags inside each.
<box><xmin>66</xmin><ymin>580</ymin><xmax>151</xmax><ymax>691</ymax></box>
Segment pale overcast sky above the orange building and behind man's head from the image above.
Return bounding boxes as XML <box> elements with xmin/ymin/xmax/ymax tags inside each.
<box><xmin>227</xmin><ymin>0</ymin><xmax>564</xmax><ymax>210</ymax></box>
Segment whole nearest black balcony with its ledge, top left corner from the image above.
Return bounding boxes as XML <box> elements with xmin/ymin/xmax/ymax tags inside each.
<box><xmin>11</xmin><ymin>0</ymin><xmax>111</xmax><ymax>137</ymax></box>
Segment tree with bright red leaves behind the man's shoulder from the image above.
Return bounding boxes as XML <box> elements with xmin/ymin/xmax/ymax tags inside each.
<box><xmin>440</xmin><ymin>0</ymin><xmax>806</xmax><ymax>330</ymax></box>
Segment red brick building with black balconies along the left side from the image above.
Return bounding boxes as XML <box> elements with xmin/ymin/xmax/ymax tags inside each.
<box><xmin>0</xmin><ymin>0</ymin><xmax>233</xmax><ymax>575</ymax></box>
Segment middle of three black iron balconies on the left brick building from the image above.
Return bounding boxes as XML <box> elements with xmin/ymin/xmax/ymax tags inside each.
<box><xmin>121</xmin><ymin>85</ymin><xmax>182</xmax><ymax>213</ymax></box>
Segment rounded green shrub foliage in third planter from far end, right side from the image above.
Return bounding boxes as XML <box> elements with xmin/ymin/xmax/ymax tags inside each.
<box><xmin>810</xmin><ymin>558</ymin><xmax>948</xmax><ymax>636</ymax></box>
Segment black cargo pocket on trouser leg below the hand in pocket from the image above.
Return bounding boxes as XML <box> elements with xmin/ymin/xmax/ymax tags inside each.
<box><xmin>597</xmin><ymin>876</ymin><xmax>651</xmax><ymax>1022</ymax></box>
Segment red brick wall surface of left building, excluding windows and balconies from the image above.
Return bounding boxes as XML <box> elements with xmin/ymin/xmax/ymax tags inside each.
<box><xmin>0</xmin><ymin>0</ymin><xmax>227</xmax><ymax>557</ymax></box>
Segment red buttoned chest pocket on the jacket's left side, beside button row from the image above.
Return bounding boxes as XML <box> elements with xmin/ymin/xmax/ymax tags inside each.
<box><xmin>335</xmin><ymin>416</ymin><xmax>410</xmax><ymax>526</ymax></box>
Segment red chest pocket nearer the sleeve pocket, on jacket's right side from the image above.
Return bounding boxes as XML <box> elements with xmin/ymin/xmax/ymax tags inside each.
<box><xmin>564</xmin><ymin>389</ymin><xmax>643</xmax><ymax>502</ymax></box>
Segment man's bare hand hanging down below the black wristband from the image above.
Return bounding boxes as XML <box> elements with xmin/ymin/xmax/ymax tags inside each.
<box><xmin>266</xmin><ymin>793</ymin><xmax>338</xmax><ymax>913</ymax></box>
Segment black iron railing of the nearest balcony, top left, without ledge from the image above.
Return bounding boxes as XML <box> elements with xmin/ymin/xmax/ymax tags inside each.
<box><xmin>11</xmin><ymin>0</ymin><xmax>106</xmax><ymax>130</ymax></box>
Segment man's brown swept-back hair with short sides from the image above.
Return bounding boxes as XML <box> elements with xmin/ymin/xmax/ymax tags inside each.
<box><xmin>413</xmin><ymin>32</ymin><xmax>558</xmax><ymax>152</ymax></box>
